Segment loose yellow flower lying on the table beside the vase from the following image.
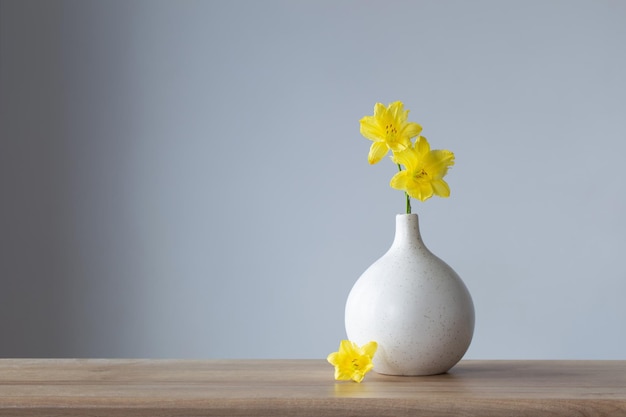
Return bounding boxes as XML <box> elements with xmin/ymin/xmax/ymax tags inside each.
<box><xmin>326</xmin><ymin>340</ymin><xmax>378</xmax><ymax>382</ymax></box>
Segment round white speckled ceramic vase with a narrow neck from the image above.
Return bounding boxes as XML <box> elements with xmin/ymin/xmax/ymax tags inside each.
<box><xmin>345</xmin><ymin>214</ymin><xmax>474</xmax><ymax>375</ymax></box>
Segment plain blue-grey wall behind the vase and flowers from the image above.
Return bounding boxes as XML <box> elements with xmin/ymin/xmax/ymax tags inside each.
<box><xmin>0</xmin><ymin>0</ymin><xmax>626</xmax><ymax>359</ymax></box>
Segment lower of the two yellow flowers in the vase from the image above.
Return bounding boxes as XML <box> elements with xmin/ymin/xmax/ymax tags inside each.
<box><xmin>389</xmin><ymin>136</ymin><xmax>454</xmax><ymax>201</ymax></box>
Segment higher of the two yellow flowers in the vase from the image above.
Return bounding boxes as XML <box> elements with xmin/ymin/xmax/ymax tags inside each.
<box><xmin>360</xmin><ymin>101</ymin><xmax>422</xmax><ymax>164</ymax></box>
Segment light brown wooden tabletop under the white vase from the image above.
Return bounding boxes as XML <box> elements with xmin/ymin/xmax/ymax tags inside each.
<box><xmin>0</xmin><ymin>359</ymin><xmax>626</xmax><ymax>417</ymax></box>
